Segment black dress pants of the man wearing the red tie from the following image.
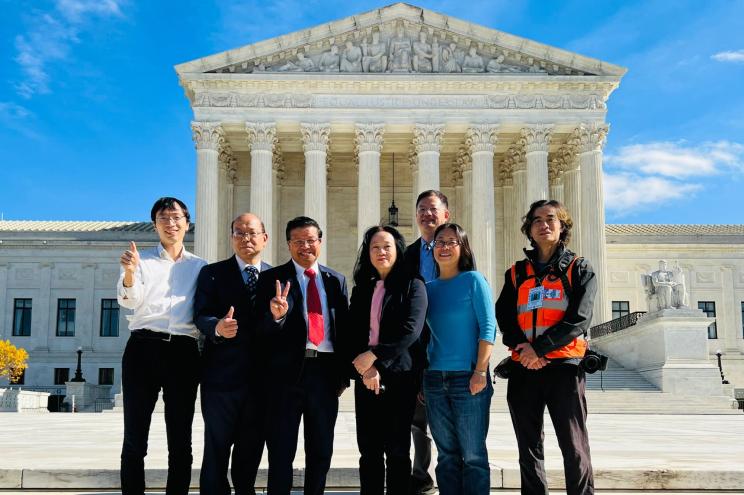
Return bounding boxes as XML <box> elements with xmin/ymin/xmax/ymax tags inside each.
<box><xmin>266</xmin><ymin>353</ymin><xmax>340</xmax><ymax>495</ymax></box>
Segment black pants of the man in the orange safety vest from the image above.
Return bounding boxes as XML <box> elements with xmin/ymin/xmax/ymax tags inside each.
<box><xmin>506</xmin><ymin>364</ymin><xmax>594</xmax><ymax>495</ymax></box>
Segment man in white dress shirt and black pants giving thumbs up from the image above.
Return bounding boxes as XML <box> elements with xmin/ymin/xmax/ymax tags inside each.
<box><xmin>117</xmin><ymin>197</ymin><xmax>206</xmax><ymax>495</ymax></box>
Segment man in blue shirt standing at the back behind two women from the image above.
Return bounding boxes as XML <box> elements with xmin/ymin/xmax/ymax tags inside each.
<box><xmin>405</xmin><ymin>189</ymin><xmax>449</xmax><ymax>495</ymax></box>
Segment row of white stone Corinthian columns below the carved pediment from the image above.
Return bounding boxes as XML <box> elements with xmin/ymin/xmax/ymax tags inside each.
<box><xmin>192</xmin><ymin>122</ymin><xmax>609</xmax><ymax>321</ymax></box>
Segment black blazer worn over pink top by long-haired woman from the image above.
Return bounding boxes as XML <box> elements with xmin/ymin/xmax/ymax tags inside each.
<box><xmin>348</xmin><ymin>277</ymin><xmax>427</xmax><ymax>378</ymax></box>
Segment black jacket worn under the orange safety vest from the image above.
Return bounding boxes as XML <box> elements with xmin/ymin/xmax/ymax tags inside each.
<box><xmin>496</xmin><ymin>244</ymin><xmax>597</xmax><ymax>357</ymax></box>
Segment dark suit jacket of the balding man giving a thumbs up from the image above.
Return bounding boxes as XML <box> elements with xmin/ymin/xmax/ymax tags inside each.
<box><xmin>194</xmin><ymin>256</ymin><xmax>271</xmax><ymax>389</ymax></box>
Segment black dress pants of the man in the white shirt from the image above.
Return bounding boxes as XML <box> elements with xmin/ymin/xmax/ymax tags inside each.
<box><xmin>121</xmin><ymin>331</ymin><xmax>200</xmax><ymax>495</ymax></box>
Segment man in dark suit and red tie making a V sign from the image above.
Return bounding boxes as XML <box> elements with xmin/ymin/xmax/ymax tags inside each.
<box><xmin>256</xmin><ymin>217</ymin><xmax>350</xmax><ymax>495</ymax></box>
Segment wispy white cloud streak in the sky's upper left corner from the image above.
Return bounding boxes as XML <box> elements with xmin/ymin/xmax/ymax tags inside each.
<box><xmin>15</xmin><ymin>0</ymin><xmax>122</xmax><ymax>99</ymax></box>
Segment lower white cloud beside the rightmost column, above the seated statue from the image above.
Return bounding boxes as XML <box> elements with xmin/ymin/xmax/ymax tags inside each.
<box><xmin>604</xmin><ymin>173</ymin><xmax>702</xmax><ymax>215</ymax></box>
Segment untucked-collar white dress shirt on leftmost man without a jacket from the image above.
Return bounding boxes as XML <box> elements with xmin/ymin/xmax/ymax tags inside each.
<box><xmin>116</xmin><ymin>244</ymin><xmax>207</xmax><ymax>338</ymax></box>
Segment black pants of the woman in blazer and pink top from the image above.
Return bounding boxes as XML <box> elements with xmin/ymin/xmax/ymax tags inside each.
<box><xmin>354</xmin><ymin>371</ymin><xmax>418</xmax><ymax>495</ymax></box>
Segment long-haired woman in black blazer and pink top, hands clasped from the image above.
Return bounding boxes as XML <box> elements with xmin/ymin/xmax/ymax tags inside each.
<box><xmin>347</xmin><ymin>226</ymin><xmax>427</xmax><ymax>495</ymax></box>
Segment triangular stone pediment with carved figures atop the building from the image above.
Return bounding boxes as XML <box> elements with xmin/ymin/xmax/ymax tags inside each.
<box><xmin>176</xmin><ymin>3</ymin><xmax>626</xmax><ymax>77</ymax></box>
